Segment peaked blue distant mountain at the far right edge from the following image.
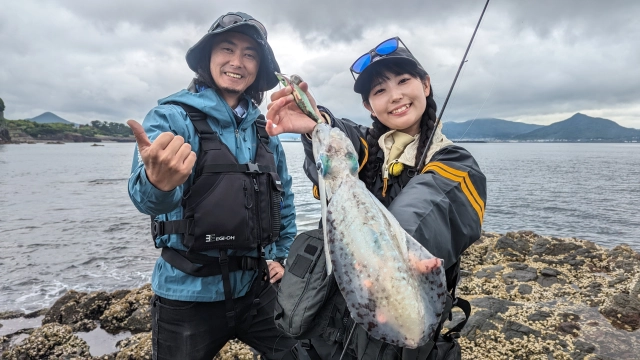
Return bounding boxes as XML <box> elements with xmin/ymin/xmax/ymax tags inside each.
<box><xmin>513</xmin><ymin>113</ymin><xmax>640</xmax><ymax>141</ymax></box>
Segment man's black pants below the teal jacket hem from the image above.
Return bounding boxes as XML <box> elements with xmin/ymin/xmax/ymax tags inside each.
<box><xmin>151</xmin><ymin>279</ymin><xmax>296</xmax><ymax>360</ymax></box>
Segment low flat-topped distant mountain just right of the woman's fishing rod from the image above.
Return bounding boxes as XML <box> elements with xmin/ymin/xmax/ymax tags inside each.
<box><xmin>442</xmin><ymin>118</ymin><xmax>543</xmax><ymax>140</ymax></box>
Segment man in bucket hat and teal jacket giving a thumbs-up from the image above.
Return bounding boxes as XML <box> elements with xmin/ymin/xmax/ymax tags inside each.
<box><xmin>128</xmin><ymin>12</ymin><xmax>296</xmax><ymax>360</ymax></box>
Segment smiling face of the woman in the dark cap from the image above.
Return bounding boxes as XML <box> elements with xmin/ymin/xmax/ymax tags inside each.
<box><xmin>364</xmin><ymin>72</ymin><xmax>431</xmax><ymax>136</ymax></box>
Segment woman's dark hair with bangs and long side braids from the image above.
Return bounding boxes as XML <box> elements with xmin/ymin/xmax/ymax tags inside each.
<box><xmin>359</xmin><ymin>61</ymin><xmax>438</xmax><ymax>190</ymax></box>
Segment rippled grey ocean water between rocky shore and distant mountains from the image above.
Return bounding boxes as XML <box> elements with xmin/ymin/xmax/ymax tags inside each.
<box><xmin>0</xmin><ymin>142</ymin><xmax>640</xmax><ymax>311</ymax></box>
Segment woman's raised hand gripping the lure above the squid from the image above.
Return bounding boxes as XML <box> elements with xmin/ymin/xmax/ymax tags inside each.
<box><xmin>267</xmin><ymin>82</ymin><xmax>321</xmax><ymax>136</ymax></box>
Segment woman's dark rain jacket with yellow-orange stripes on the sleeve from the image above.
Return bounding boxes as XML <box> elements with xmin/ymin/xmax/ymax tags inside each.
<box><xmin>302</xmin><ymin>107</ymin><xmax>487</xmax><ymax>282</ymax></box>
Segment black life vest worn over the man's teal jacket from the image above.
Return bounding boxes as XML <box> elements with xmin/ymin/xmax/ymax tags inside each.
<box><xmin>152</xmin><ymin>103</ymin><xmax>283</xmax><ymax>277</ymax></box>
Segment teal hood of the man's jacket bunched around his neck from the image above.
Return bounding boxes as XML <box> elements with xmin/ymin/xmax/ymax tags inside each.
<box><xmin>158</xmin><ymin>89</ymin><xmax>260</xmax><ymax>128</ymax></box>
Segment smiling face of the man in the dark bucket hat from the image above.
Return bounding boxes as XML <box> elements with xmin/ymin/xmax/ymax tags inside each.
<box><xmin>210</xmin><ymin>31</ymin><xmax>260</xmax><ymax>100</ymax></box>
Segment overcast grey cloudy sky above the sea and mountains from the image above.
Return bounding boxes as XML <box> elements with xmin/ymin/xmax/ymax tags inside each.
<box><xmin>0</xmin><ymin>0</ymin><xmax>640</xmax><ymax>128</ymax></box>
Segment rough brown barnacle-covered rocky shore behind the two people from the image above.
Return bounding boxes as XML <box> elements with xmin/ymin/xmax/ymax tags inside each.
<box><xmin>0</xmin><ymin>231</ymin><xmax>640</xmax><ymax>360</ymax></box>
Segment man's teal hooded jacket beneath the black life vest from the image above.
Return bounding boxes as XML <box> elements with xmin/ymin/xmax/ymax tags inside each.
<box><xmin>129</xmin><ymin>89</ymin><xmax>296</xmax><ymax>301</ymax></box>
